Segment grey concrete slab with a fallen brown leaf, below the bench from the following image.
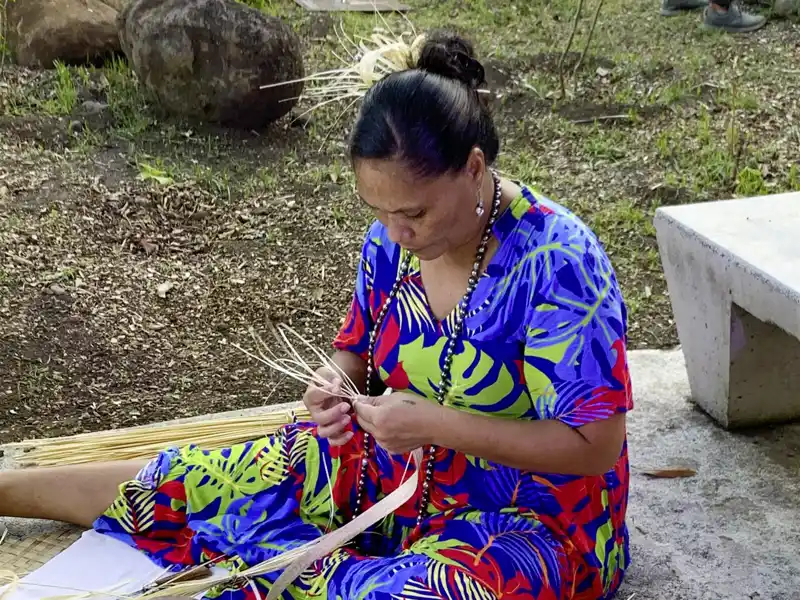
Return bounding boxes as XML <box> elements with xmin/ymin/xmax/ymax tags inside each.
<box><xmin>0</xmin><ymin>349</ymin><xmax>800</xmax><ymax>600</ymax></box>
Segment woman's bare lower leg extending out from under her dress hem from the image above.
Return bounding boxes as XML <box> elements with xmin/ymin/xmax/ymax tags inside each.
<box><xmin>0</xmin><ymin>461</ymin><xmax>144</xmax><ymax>527</ymax></box>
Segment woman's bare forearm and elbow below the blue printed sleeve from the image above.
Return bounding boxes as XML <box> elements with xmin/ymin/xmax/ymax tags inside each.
<box><xmin>431</xmin><ymin>408</ymin><xmax>625</xmax><ymax>475</ymax></box>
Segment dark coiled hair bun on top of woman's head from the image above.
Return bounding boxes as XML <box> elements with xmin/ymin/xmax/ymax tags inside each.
<box><xmin>417</xmin><ymin>31</ymin><xmax>486</xmax><ymax>90</ymax></box>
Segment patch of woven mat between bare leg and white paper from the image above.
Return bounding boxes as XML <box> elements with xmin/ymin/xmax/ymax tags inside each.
<box><xmin>0</xmin><ymin>524</ymin><xmax>83</xmax><ymax>577</ymax></box>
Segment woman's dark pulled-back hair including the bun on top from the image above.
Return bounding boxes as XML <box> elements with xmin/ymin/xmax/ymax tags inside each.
<box><xmin>350</xmin><ymin>31</ymin><xmax>500</xmax><ymax>177</ymax></box>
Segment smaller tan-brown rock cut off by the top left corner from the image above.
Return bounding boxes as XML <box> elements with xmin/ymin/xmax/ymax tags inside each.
<box><xmin>5</xmin><ymin>0</ymin><xmax>124</xmax><ymax>68</ymax></box>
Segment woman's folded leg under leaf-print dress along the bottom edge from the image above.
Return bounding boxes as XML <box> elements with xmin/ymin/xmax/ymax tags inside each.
<box><xmin>256</xmin><ymin>515</ymin><xmax>568</xmax><ymax>600</ymax></box>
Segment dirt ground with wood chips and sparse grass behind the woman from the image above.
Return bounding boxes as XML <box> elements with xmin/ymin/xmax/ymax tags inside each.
<box><xmin>0</xmin><ymin>0</ymin><xmax>800</xmax><ymax>442</ymax></box>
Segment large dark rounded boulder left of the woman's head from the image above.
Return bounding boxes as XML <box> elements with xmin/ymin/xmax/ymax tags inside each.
<box><xmin>119</xmin><ymin>0</ymin><xmax>303</xmax><ymax>129</ymax></box>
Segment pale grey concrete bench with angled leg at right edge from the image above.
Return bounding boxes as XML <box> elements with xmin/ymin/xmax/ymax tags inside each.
<box><xmin>655</xmin><ymin>193</ymin><xmax>800</xmax><ymax>429</ymax></box>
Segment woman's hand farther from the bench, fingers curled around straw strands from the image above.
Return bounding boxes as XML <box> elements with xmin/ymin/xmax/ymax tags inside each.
<box><xmin>303</xmin><ymin>367</ymin><xmax>353</xmax><ymax>446</ymax></box>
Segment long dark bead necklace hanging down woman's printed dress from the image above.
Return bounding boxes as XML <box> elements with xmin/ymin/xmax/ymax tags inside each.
<box><xmin>353</xmin><ymin>171</ymin><xmax>502</xmax><ymax>525</ymax></box>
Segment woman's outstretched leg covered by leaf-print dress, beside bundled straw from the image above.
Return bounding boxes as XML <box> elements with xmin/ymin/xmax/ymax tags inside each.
<box><xmin>94</xmin><ymin>423</ymin><xmax>340</xmax><ymax>568</ymax></box>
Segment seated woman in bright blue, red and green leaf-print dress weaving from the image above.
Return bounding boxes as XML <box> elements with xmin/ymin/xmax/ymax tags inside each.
<box><xmin>0</xmin><ymin>34</ymin><xmax>632</xmax><ymax>600</ymax></box>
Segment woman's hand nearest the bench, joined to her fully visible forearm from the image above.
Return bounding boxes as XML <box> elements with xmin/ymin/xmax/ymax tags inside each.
<box><xmin>353</xmin><ymin>392</ymin><xmax>445</xmax><ymax>454</ymax></box>
